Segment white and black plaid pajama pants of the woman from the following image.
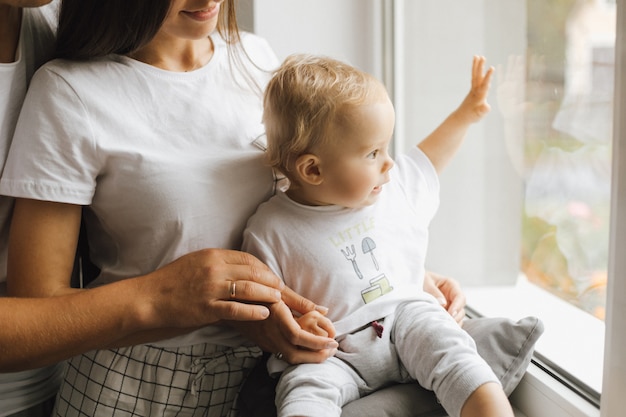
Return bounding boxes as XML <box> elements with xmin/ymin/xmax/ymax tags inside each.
<box><xmin>52</xmin><ymin>344</ymin><xmax>261</xmax><ymax>417</ymax></box>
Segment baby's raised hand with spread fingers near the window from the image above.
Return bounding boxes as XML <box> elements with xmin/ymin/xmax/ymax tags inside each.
<box><xmin>457</xmin><ymin>56</ymin><xmax>494</xmax><ymax>123</ymax></box>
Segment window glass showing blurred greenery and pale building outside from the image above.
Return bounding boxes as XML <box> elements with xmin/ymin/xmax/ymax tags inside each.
<box><xmin>520</xmin><ymin>0</ymin><xmax>615</xmax><ymax>319</ymax></box>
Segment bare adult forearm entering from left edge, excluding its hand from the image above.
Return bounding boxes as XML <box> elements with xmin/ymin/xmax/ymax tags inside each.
<box><xmin>0</xmin><ymin>279</ymin><xmax>178</xmax><ymax>372</ymax></box>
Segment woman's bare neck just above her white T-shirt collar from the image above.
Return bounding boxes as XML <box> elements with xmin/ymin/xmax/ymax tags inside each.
<box><xmin>129</xmin><ymin>37</ymin><xmax>214</xmax><ymax>72</ymax></box>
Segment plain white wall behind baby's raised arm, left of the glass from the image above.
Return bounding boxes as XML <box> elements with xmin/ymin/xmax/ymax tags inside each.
<box><xmin>404</xmin><ymin>0</ymin><xmax>526</xmax><ymax>285</ymax></box>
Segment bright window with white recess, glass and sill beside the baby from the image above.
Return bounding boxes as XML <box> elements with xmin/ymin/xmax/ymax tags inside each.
<box><xmin>393</xmin><ymin>0</ymin><xmax>626</xmax><ymax>412</ymax></box>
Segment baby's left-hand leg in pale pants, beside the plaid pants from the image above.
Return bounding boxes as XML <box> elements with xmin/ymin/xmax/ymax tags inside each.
<box><xmin>276</xmin><ymin>358</ymin><xmax>359</xmax><ymax>417</ymax></box>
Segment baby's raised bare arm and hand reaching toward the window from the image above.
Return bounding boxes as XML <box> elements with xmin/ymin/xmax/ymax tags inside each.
<box><xmin>417</xmin><ymin>56</ymin><xmax>494</xmax><ymax>172</ymax></box>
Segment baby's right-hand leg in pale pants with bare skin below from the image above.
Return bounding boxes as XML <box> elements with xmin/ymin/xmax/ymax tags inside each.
<box><xmin>391</xmin><ymin>299</ymin><xmax>513</xmax><ymax>417</ymax></box>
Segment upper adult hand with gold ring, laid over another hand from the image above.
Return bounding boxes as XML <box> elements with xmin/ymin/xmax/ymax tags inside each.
<box><xmin>138</xmin><ymin>249</ymin><xmax>284</xmax><ymax>327</ymax></box>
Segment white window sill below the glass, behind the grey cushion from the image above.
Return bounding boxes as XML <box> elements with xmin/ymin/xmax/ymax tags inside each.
<box><xmin>464</xmin><ymin>277</ymin><xmax>604</xmax><ymax>417</ymax></box>
